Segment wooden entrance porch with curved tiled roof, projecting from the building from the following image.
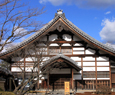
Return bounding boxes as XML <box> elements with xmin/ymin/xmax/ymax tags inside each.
<box><xmin>41</xmin><ymin>54</ymin><xmax>81</xmax><ymax>90</ymax></box>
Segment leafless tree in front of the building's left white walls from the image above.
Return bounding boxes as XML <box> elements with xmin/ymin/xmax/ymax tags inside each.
<box><xmin>11</xmin><ymin>41</ymin><xmax>56</xmax><ymax>95</ymax></box>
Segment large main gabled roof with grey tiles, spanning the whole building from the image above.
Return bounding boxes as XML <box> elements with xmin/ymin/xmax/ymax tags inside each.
<box><xmin>0</xmin><ymin>10</ymin><xmax>115</xmax><ymax>57</ymax></box>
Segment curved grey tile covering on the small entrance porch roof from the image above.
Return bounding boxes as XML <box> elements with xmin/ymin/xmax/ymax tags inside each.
<box><xmin>41</xmin><ymin>54</ymin><xmax>81</xmax><ymax>71</ymax></box>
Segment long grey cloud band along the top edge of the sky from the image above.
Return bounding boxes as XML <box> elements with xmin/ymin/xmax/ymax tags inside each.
<box><xmin>39</xmin><ymin>0</ymin><xmax>115</xmax><ymax>8</ymax></box>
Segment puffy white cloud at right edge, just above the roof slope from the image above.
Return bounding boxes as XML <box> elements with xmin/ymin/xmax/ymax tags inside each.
<box><xmin>100</xmin><ymin>18</ymin><xmax>115</xmax><ymax>43</ymax></box>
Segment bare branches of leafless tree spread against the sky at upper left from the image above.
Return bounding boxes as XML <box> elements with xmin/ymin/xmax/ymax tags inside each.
<box><xmin>0</xmin><ymin>0</ymin><xmax>45</xmax><ymax>52</ymax></box>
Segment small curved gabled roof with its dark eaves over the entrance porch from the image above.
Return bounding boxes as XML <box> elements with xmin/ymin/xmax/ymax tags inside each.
<box><xmin>41</xmin><ymin>54</ymin><xmax>81</xmax><ymax>71</ymax></box>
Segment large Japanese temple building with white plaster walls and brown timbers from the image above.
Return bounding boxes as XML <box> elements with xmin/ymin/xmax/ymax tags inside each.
<box><xmin>0</xmin><ymin>10</ymin><xmax>115</xmax><ymax>90</ymax></box>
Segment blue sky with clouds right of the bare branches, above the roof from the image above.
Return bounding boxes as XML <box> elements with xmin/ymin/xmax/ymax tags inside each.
<box><xmin>19</xmin><ymin>0</ymin><xmax>115</xmax><ymax>44</ymax></box>
